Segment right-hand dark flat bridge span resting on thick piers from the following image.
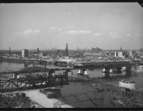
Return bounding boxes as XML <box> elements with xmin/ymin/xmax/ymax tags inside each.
<box><xmin>74</xmin><ymin>61</ymin><xmax>136</xmax><ymax>78</ymax></box>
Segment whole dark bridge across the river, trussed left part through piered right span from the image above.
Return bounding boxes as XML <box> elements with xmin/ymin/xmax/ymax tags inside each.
<box><xmin>0</xmin><ymin>61</ymin><xmax>141</xmax><ymax>92</ymax></box>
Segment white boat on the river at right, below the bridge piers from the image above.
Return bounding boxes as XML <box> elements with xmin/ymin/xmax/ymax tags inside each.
<box><xmin>119</xmin><ymin>80</ymin><xmax>136</xmax><ymax>90</ymax></box>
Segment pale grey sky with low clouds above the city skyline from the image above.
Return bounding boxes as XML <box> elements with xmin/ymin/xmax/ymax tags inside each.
<box><xmin>0</xmin><ymin>2</ymin><xmax>143</xmax><ymax>50</ymax></box>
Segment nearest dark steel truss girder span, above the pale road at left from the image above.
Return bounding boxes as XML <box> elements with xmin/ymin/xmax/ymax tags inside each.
<box><xmin>0</xmin><ymin>75</ymin><xmax>68</xmax><ymax>92</ymax></box>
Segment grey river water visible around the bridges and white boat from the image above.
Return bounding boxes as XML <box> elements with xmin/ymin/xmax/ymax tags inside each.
<box><xmin>0</xmin><ymin>62</ymin><xmax>143</xmax><ymax>107</ymax></box>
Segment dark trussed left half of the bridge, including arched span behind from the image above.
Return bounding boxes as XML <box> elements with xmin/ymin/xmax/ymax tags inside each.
<box><xmin>0</xmin><ymin>67</ymin><xmax>70</xmax><ymax>93</ymax></box>
